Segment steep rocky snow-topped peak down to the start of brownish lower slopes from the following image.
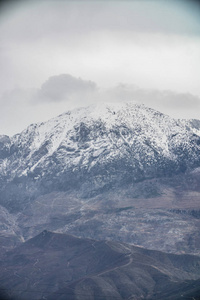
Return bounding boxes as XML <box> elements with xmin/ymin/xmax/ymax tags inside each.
<box><xmin>0</xmin><ymin>103</ymin><xmax>200</xmax><ymax>210</ymax></box>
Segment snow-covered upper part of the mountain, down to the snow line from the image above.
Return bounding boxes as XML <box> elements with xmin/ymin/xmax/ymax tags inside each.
<box><xmin>0</xmin><ymin>102</ymin><xmax>200</xmax><ymax>188</ymax></box>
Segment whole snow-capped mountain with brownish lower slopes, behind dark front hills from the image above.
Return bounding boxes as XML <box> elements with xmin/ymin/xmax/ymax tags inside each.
<box><xmin>0</xmin><ymin>103</ymin><xmax>200</xmax><ymax>255</ymax></box>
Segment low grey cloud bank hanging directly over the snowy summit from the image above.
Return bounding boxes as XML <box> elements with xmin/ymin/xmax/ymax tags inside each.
<box><xmin>0</xmin><ymin>74</ymin><xmax>200</xmax><ymax>135</ymax></box>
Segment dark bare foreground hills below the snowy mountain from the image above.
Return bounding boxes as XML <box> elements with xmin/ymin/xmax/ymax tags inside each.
<box><xmin>0</xmin><ymin>230</ymin><xmax>200</xmax><ymax>300</ymax></box>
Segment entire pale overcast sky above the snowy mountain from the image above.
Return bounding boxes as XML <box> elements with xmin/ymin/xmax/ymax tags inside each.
<box><xmin>0</xmin><ymin>0</ymin><xmax>200</xmax><ymax>135</ymax></box>
